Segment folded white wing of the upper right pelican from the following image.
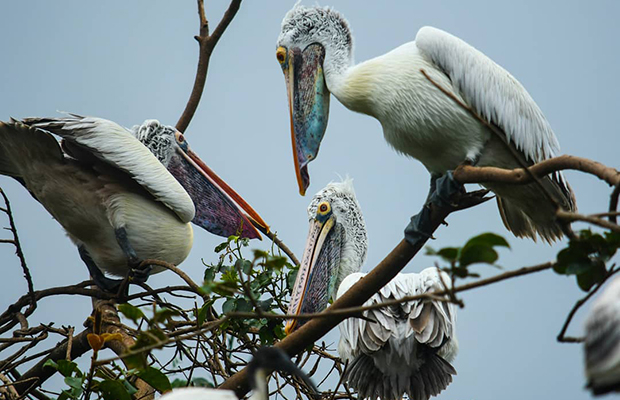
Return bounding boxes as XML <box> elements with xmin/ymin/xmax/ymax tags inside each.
<box><xmin>415</xmin><ymin>27</ymin><xmax>560</xmax><ymax>163</ymax></box>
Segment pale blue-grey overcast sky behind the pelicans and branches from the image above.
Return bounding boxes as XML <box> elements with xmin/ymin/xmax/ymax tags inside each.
<box><xmin>0</xmin><ymin>0</ymin><xmax>620</xmax><ymax>400</ymax></box>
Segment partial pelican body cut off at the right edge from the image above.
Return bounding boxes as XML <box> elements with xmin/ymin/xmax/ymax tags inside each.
<box><xmin>584</xmin><ymin>278</ymin><xmax>620</xmax><ymax>395</ymax></box>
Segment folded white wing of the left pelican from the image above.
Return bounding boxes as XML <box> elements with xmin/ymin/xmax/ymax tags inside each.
<box><xmin>24</xmin><ymin>114</ymin><xmax>195</xmax><ymax>222</ymax></box>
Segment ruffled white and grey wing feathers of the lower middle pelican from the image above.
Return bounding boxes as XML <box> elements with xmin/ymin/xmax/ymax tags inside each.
<box><xmin>338</xmin><ymin>268</ymin><xmax>456</xmax><ymax>359</ymax></box>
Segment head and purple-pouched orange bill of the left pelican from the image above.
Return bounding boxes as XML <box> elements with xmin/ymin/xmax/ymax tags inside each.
<box><xmin>132</xmin><ymin>120</ymin><xmax>267</xmax><ymax>239</ymax></box>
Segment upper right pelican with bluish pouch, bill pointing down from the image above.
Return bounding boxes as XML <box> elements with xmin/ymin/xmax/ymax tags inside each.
<box><xmin>276</xmin><ymin>4</ymin><xmax>576</xmax><ymax>242</ymax></box>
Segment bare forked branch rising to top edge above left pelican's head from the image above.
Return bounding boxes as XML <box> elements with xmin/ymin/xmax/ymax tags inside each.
<box><xmin>176</xmin><ymin>0</ymin><xmax>241</xmax><ymax>132</ymax></box>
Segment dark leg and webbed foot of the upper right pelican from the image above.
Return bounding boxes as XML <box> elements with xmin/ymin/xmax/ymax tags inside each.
<box><xmin>405</xmin><ymin>171</ymin><xmax>465</xmax><ymax>246</ymax></box>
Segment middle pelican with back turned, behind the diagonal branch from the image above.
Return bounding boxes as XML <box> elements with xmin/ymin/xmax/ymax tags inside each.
<box><xmin>285</xmin><ymin>180</ymin><xmax>458</xmax><ymax>400</ymax></box>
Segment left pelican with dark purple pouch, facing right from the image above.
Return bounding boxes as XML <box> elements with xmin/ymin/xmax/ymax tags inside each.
<box><xmin>0</xmin><ymin>114</ymin><xmax>267</xmax><ymax>291</ymax></box>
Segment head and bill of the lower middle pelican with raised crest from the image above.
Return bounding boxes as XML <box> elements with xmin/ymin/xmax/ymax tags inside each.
<box><xmin>285</xmin><ymin>179</ymin><xmax>368</xmax><ymax>334</ymax></box>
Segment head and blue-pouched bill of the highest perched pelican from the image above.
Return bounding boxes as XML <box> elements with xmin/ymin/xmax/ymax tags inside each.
<box><xmin>276</xmin><ymin>4</ymin><xmax>353</xmax><ymax>196</ymax></box>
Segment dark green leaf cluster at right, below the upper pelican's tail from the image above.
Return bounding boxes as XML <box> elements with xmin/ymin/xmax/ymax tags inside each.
<box><xmin>553</xmin><ymin>229</ymin><xmax>620</xmax><ymax>292</ymax></box>
